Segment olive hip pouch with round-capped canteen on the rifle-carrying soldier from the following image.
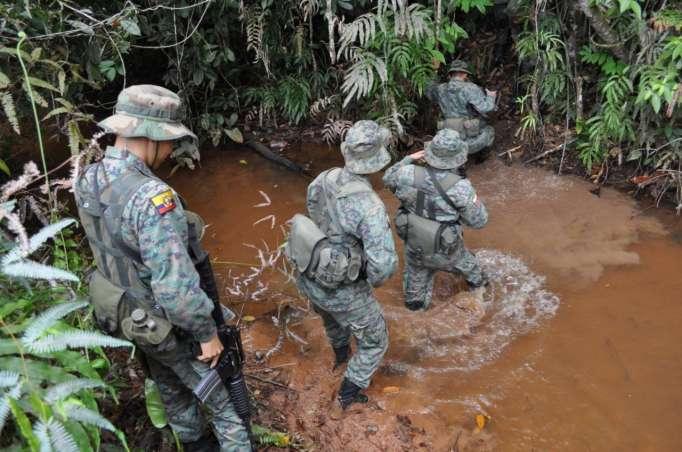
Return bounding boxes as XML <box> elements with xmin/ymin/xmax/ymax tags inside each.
<box><xmin>121</xmin><ymin>308</ymin><xmax>177</xmax><ymax>358</ymax></box>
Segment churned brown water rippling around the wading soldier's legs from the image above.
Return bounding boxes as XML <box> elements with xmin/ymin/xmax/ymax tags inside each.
<box><xmin>386</xmin><ymin>249</ymin><xmax>559</xmax><ymax>376</ymax></box>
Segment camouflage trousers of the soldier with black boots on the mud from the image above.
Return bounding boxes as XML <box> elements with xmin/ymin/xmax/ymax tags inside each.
<box><xmin>313</xmin><ymin>295</ymin><xmax>388</xmax><ymax>388</ymax></box>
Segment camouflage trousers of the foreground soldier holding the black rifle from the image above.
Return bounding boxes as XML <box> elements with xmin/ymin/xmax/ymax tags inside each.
<box><xmin>146</xmin><ymin>348</ymin><xmax>251</xmax><ymax>452</ymax></box>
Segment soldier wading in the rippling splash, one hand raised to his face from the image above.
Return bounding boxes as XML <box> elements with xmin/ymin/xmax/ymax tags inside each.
<box><xmin>384</xmin><ymin>129</ymin><xmax>488</xmax><ymax>311</ymax></box>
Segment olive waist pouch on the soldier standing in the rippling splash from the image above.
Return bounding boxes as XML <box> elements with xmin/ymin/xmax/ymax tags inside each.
<box><xmin>395</xmin><ymin>207</ymin><xmax>459</xmax><ymax>260</ymax></box>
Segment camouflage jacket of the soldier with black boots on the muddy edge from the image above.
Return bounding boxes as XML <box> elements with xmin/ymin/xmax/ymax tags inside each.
<box><xmin>299</xmin><ymin>169</ymin><xmax>398</xmax><ymax>311</ymax></box>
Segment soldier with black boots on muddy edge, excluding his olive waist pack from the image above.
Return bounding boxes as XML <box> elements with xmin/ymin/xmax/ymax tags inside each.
<box><xmin>297</xmin><ymin>121</ymin><xmax>397</xmax><ymax>414</ymax></box>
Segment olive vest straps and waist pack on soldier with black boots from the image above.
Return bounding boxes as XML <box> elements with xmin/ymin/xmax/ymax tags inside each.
<box><xmin>285</xmin><ymin>168</ymin><xmax>372</xmax><ymax>289</ymax></box>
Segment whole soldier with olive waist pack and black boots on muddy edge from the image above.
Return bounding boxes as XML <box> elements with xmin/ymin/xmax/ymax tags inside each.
<box><xmin>287</xmin><ymin>121</ymin><xmax>397</xmax><ymax>418</ymax></box>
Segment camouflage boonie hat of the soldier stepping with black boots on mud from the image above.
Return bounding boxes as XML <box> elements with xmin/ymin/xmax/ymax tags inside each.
<box><xmin>341</xmin><ymin>120</ymin><xmax>391</xmax><ymax>174</ymax></box>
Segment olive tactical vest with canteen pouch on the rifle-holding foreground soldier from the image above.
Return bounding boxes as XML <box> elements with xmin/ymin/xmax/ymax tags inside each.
<box><xmin>76</xmin><ymin>162</ymin><xmax>207</xmax><ymax>352</ymax></box>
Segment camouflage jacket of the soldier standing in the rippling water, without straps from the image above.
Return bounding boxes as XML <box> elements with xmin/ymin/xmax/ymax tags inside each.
<box><xmin>384</xmin><ymin>156</ymin><xmax>488</xmax><ymax>229</ymax></box>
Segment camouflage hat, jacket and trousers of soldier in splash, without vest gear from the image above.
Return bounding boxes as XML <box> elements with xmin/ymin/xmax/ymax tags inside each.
<box><xmin>383</xmin><ymin>129</ymin><xmax>488</xmax><ymax>308</ymax></box>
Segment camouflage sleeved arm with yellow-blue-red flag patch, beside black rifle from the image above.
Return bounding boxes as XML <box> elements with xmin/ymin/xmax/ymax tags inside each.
<box><xmin>130</xmin><ymin>181</ymin><xmax>216</xmax><ymax>342</ymax></box>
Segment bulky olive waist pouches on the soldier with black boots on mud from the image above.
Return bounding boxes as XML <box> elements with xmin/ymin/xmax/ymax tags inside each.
<box><xmin>285</xmin><ymin>214</ymin><xmax>363</xmax><ymax>289</ymax></box>
